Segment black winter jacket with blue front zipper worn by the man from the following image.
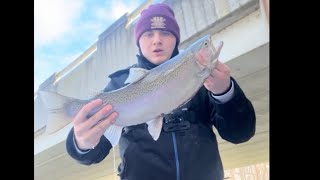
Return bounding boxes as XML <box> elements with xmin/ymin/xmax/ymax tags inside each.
<box><xmin>66</xmin><ymin>54</ymin><xmax>256</xmax><ymax>180</ymax></box>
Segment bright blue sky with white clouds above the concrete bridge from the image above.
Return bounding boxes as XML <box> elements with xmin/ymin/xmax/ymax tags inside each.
<box><xmin>34</xmin><ymin>0</ymin><xmax>150</xmax><ymax>92</ymax></box>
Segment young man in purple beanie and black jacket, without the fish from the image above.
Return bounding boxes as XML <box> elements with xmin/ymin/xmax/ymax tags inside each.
<box><xmin>66</xmin><ymin>4</ymin><xmax>256</xmax><ymax>180</ymax></box>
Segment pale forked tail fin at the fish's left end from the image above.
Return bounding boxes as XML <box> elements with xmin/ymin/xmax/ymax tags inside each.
<box><xmin>39</xmin><ymin>91</ymin><xmax>73</xmax><ymax>134</ymax></box>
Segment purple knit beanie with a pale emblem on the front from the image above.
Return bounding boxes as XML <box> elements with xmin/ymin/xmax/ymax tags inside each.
<box><xmin>134</xmin><ymin>4</ymin><xmax>180</xmax><ymax>46</ymax></box>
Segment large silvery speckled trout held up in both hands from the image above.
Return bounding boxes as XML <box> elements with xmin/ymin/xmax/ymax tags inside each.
<box><xmin>39</xmin><ymin>35</ymin><xmax>223</xmax><ymax>146</ymax></box>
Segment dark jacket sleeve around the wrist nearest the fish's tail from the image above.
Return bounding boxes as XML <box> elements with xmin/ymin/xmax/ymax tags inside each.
<box><xmin>66</xmin><ymin>81</ymin><xmax>115</xmax><ymax>165</ymax></box>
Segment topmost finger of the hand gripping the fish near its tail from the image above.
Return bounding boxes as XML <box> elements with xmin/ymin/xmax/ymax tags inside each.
<box><xmin>73</xmin><ymin>99</ymin><xmax>102</xmax><ymax>125</ymax></box>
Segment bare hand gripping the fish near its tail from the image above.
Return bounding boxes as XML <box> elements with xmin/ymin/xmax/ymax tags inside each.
<box><xmin>72</xmin><ymin>99</ymin><xmax>118</xmax><ymax>150</ymax></box>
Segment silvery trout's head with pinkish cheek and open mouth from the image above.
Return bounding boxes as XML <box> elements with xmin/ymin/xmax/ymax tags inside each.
<box><xmin>193</xmin><ymin>35</ymin><xmax>223</xmax><ymax>69</ymax></box>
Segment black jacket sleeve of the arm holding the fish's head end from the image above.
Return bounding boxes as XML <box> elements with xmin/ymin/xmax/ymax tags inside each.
<box><xmin>209</xmin><ymin>77</ymin><xmax>256</xmax><ymax>144</ymax></box>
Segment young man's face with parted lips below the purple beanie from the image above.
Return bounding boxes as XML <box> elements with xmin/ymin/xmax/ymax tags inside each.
<box><xmin>139</xmin><ymin>30</ymin><xmax>177</xmax><ymax>65</ymax></box>
